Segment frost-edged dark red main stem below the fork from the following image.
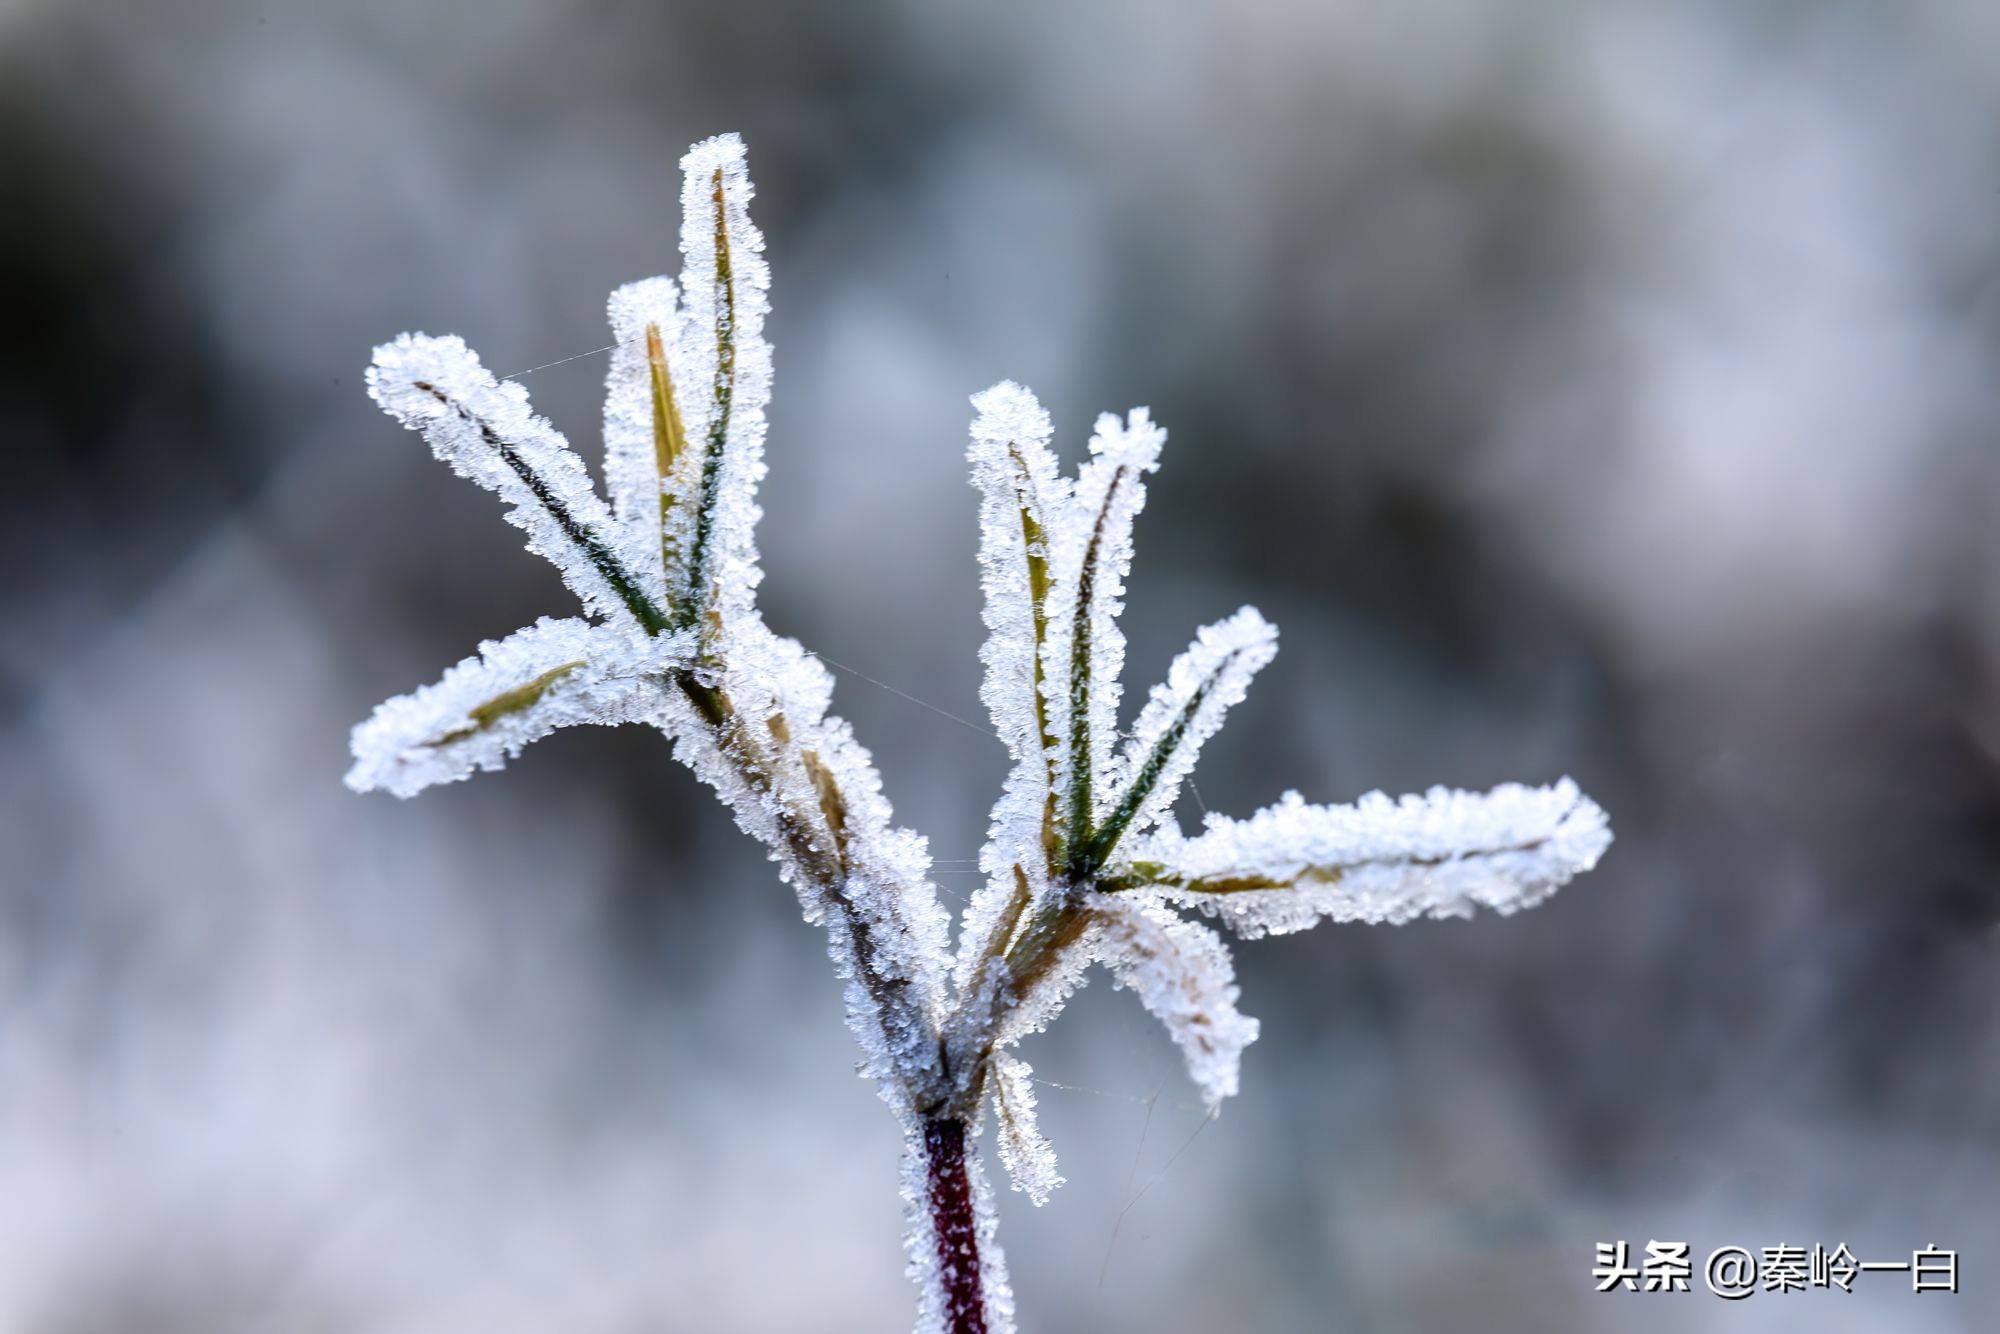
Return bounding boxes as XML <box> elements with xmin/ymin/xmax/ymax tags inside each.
<box><xmin>902</xmin><ymin>1116</ymin><xmax>1014</xmax><ymax>1334</ymax></box>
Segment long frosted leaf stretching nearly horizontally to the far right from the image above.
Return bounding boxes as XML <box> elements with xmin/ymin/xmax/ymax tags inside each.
<box><xmin>1128</xmin><ymin>778</ymin><xmax>1612</xmax><ymax>936</ymax></box>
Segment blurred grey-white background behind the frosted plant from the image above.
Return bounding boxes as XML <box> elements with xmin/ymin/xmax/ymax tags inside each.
<box><xmin>0</xmin><ymin>0</ymin><xmax>2000</xmax><ymax>1334</ymax></box>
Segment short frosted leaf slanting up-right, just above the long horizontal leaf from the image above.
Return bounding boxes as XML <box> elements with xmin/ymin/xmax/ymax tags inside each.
<box><xmin>1116</xmin><ymin>606</ymin><xmax>1278</xmax><ymax>836</ymax></box>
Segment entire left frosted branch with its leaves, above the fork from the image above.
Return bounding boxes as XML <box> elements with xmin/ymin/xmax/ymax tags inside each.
<box><xmin>348</xmin><ymin>136</ymin><xmax>948</xmax><ymax>1114</ymax></box>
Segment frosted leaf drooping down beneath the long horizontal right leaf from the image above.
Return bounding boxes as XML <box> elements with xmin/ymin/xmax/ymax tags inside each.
<box><xmin>1090</xmin><ymin>892</ymin><xmax>1258</xmax><ymax>1108</ymax></box>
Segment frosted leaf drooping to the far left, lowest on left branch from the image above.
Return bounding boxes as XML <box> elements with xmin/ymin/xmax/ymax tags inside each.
<box><xmin>346</xmin><ymin>618</ymin><xmax>692</xmax><ymax>796</ymax></box>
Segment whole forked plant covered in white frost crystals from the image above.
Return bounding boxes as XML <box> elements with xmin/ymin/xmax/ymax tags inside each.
<box><xmin>348</xmin><ymin>136</ymin><xmax>1610</xmax><ymax>1334</ymax></box>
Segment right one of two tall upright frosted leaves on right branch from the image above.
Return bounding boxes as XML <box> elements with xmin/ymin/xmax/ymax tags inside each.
<box><xmin>1042</xmin><ymin>408</ymin><xmax>1166</xmax><ymax>820</ymax></box>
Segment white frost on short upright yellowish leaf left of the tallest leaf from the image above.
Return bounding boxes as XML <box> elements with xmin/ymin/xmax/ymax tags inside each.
<box><xmin>604</xmin><ymin>278</ymin><xmax>694</xmax><ymax>606</ymax></box>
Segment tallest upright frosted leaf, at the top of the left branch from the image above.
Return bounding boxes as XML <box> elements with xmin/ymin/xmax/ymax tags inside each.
<box><xmin>672</xmin><ymin>134</ymin><xmax>772</xmax><ymax>618</ymax></box>
